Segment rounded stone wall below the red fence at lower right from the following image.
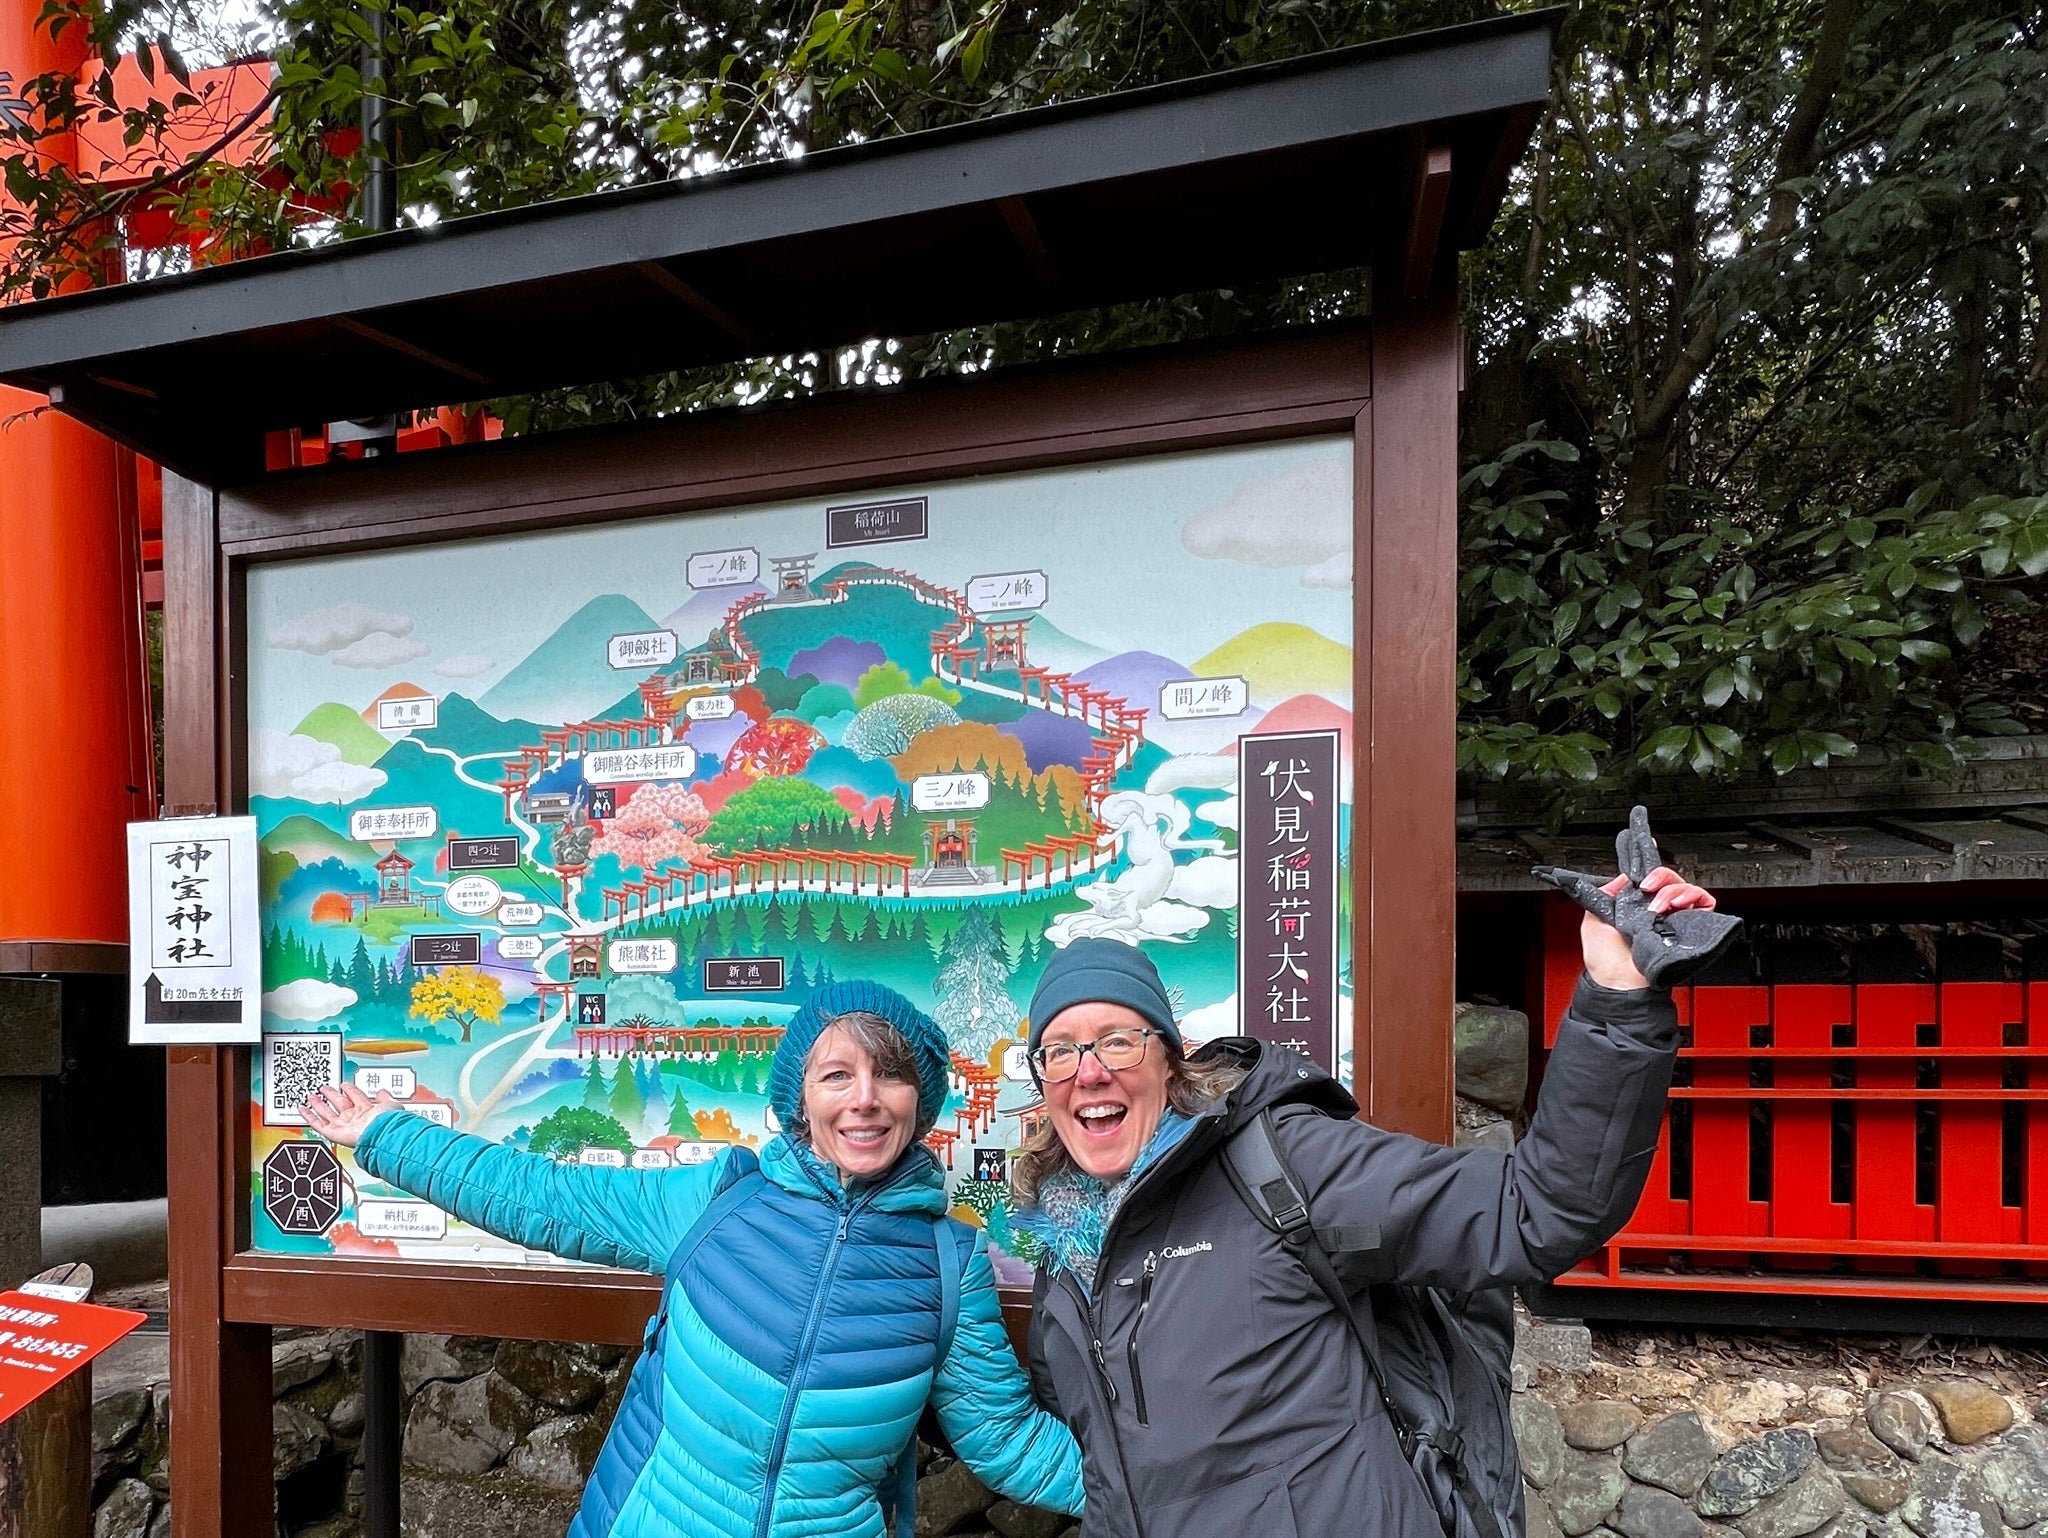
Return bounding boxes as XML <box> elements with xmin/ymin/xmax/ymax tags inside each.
<box><xmin>1511</xmin><ymin>1323</ymin><xmax>2048</xmax><ymax>1538</ymax></box>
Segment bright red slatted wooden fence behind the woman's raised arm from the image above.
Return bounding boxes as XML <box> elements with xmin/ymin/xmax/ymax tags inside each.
<box><xmin>1542</xmin><ymin>899</ymin><xmax>2048</xmax><ymax>1302</ymax></box>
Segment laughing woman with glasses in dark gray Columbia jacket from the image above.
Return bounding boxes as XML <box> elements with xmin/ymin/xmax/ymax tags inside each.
<box><xmin>1016</xmin><ymin>827</ymin><xmax>1726</xmax><ymax>1538</ymax></box>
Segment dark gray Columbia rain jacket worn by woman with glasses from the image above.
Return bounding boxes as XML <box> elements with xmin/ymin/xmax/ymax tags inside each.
<box><xmin>1030</xmin><ymin>979</ymin><xmax>1677</xmax><ymax>1538</ymax></box>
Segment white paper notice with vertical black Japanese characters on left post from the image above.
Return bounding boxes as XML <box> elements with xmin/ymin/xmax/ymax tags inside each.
<box><xmin>129</xmin><ymin>817</ymin><xmax>262</xmax><ymax>1046</ymax></box>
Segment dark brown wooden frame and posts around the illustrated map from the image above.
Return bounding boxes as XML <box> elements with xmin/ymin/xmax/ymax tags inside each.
<box><xmin>164</xmin><ymin>303</ymin><xmax>1460</xmax><ymax>1538</ymax></box>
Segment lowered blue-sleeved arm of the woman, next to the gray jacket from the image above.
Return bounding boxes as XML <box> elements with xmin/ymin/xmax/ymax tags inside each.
<box><xmin>932</xmin><ymin>1243</ymin><xmax>1083</xmax><ymax>1515</ymax></box>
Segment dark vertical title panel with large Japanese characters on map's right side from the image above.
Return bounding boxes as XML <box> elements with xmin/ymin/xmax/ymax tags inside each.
<box><xmin>1237</xmin><ymin>731</ymin><xmax>1341</xmax><ymax>1073</ymax></box>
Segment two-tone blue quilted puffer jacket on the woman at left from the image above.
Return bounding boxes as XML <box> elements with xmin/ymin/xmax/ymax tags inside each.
<box><xmin>356</xmin><ymin>1112</ymin><xmax>1081</xmax><ymax>1538</ymax></box>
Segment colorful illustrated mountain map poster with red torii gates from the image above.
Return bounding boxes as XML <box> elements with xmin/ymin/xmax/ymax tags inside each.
<box><xmin>248</xmin><ymin>438</ymin><xmax>1354</xmax><ymax>1280</ymax></box>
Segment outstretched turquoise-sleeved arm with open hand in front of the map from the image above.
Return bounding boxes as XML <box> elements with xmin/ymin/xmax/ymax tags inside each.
<box><xmin>305</xmin><ymin>1083</ymin><xmax>719</xmax><ymax>1272</ymax></box>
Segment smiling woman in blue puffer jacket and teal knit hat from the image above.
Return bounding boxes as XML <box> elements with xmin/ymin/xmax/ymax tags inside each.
<box><xmin>305</xmin><ymin>983</ymin><xmax>1081</xmax><ymax>1538</ymax></box>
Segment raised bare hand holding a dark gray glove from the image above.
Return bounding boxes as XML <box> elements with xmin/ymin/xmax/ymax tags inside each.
<box><xmin>1534</xmin><ymin>807</ymin><xmax>1743</xmax><ymax>989</ymax></box>
